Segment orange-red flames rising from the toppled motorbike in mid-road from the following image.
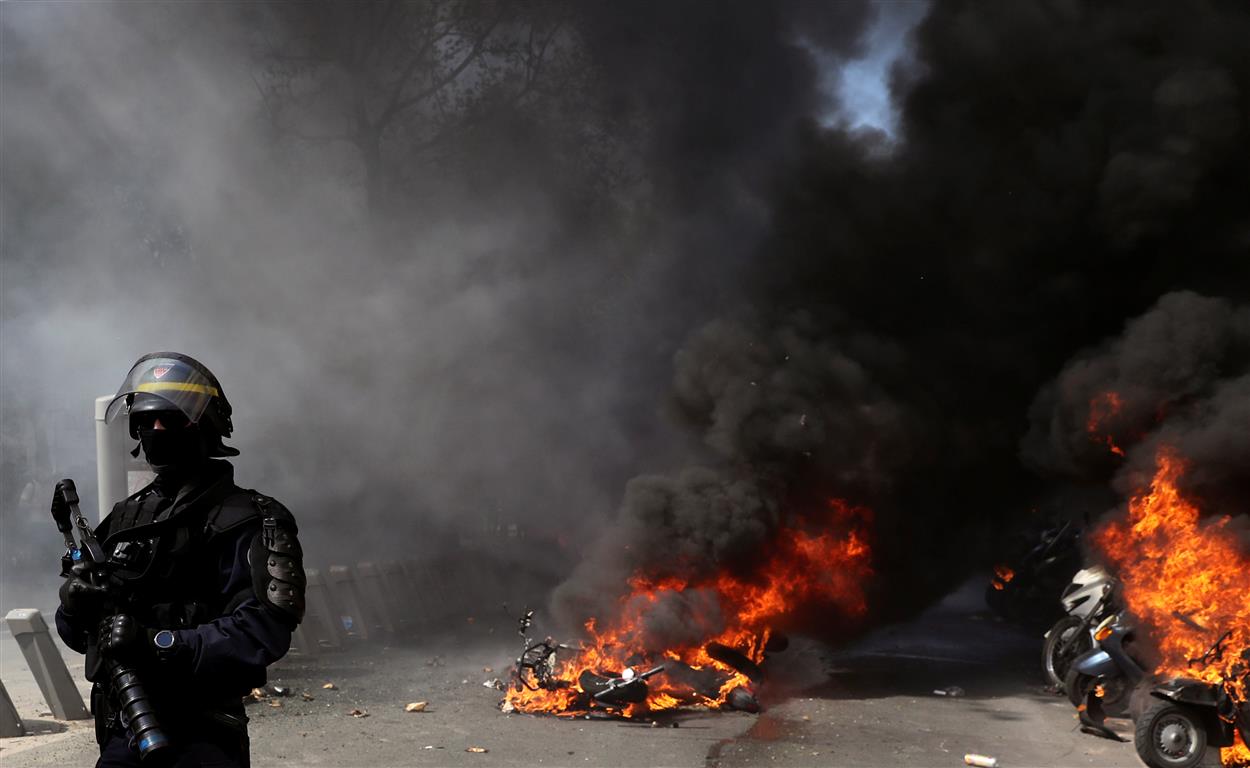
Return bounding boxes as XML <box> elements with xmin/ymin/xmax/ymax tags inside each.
<box><xmin>505</xmin><ymin>499</ymin><xmax>873</xmax><ymax>717</ymax></box>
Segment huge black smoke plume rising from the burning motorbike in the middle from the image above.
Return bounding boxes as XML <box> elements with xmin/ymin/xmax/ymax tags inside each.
<box><xmin>555</xmin><ymin>1</ymin><xmax>1250</xmax><ymax>637</ymax></box>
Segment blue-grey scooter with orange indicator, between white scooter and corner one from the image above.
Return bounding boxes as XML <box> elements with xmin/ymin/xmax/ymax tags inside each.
<box><xmin>1064</xmin><ymin>613</ymin><xmax>1146</xmax><ymax>720</ymax></box>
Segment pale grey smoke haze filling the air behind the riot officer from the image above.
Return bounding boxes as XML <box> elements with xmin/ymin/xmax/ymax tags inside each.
<box><xmin>0</xmin><ymin>0</ymin><xmax>871</xmax><ymax>612</ymax></box>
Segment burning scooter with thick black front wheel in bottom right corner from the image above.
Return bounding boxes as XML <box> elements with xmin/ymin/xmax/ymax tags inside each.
<box><xmin>1134</xmin><ymin>630</ymin><xmax>1250</xmax><ymax>768</ymax></box>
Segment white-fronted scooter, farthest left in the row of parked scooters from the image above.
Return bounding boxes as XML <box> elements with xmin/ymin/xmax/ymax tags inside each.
<box><xmin>1041</xmin><ymin>565</ymin><xmax>1119</xmax><ymax>690</ymax></box>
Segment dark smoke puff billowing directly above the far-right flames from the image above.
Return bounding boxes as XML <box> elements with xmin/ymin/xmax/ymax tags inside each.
<box><xmin>1023</xmin><ymin>291</ymin><xmax>1250</xmax><ymax>515</ymax></box>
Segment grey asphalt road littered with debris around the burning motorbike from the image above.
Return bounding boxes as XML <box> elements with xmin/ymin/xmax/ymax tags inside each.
<box><xmin>0</xmin><ymin>583</ymin><xmax>1140</xmax><ymax>768</ymax></box>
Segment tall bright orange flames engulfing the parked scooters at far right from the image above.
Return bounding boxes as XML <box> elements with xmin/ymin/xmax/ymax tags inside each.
<box><xmin>1094</xmin><ymin>448</ymin><xmax>1250</xmax><ymax>765</ymax></box>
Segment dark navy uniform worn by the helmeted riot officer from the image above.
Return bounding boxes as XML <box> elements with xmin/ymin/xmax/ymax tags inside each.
<box><xmin>56</xmin><ymin>460</ymin><xmax>304</xmax><ymax>765</ymax></box>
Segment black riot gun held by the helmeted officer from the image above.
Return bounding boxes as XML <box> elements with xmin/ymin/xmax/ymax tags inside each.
<box><xmin>53</xmin><ymin>479</ymin><xmax>170</xmax><ymax>760</ymax></box>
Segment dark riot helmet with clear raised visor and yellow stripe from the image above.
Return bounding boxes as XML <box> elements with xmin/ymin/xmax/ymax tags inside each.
<box><xmin>104</xmin><ymin>351</ymin><xmax>239</xmax><ymax>457</ymax></box>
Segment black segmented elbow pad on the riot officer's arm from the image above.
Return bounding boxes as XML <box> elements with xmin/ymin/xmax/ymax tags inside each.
<box><xmin>248</xmin><ymin>495</ymin><xmax>306</xmax><ymax>624</ymax></box>
